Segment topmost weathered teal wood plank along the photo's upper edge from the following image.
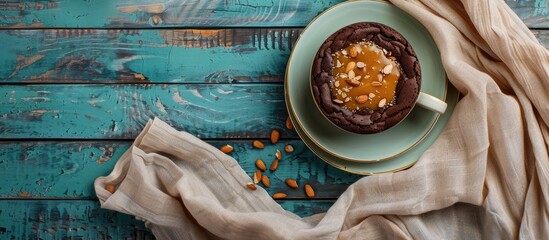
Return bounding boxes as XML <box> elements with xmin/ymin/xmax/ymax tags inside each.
<box><xmin>0</xmin><ymin>0</ymin><xmax>549</xmax><ymax>28</ymax></box>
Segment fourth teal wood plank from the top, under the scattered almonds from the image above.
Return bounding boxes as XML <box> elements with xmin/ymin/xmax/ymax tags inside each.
<box><xmin>0</xmin><ymin>140</ymin><xmax>361</xmax><ymax>199</ymax></box>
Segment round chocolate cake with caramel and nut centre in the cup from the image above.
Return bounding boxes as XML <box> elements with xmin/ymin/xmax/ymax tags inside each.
<box><xmin>311</xmin><ymin>22</ymin><xmax>421</xmax><ymax>134</ymax></box>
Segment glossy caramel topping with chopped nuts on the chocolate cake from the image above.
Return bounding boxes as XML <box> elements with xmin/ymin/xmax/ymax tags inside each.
<box><xmin>331</xmin><ymin>42</ymin><xmax>400</xmax><ymax>111</ymax></box>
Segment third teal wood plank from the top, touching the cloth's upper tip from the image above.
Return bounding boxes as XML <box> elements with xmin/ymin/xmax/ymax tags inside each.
<box><xmin>0</xmin><ymin>84</ymin><xmax>297</xmax><ymax>139</ymax></box>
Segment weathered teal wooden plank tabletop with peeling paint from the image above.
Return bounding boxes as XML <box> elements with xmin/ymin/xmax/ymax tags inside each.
<box><xmin>0</xmin><ymin>0</ymin><xmax>549</xmax><ymax>239</ymax></box>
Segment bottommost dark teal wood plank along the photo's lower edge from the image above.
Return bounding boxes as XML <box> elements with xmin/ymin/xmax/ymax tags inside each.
<box><xmin>0</xmin><ymin>200</ymin><xmax>334</xmax><ymax>239</ymax></box>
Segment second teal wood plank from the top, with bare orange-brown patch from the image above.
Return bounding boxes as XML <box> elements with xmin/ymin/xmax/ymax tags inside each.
<box><xmin>0</xmin><ymin>28</ymin><xmax>301</xmax><ymax>83</ymax></box>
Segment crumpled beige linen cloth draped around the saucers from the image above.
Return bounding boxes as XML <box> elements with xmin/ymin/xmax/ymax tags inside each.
<box><xmin>95</xmin><ymin>0</ymin><xmax>549</xmax><ymax>239</ymax></box>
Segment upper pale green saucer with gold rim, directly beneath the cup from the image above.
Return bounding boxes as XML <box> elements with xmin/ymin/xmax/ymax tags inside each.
<box><xmin>285</xmin><ymin>1</ymin><xmax>447</xmax><ymax>162</ymax></box>
